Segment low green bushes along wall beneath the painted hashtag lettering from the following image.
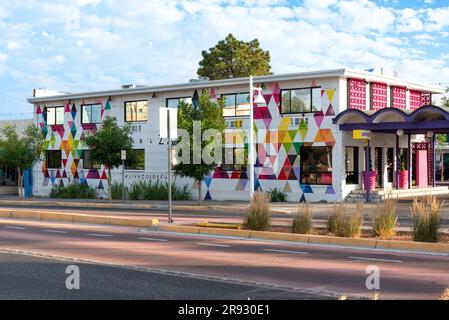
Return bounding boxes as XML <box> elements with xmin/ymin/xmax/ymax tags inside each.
<box><xmin>121</xmin><ymin>181</ymin><xmax>191</xmax><ymax>200</ymax></box>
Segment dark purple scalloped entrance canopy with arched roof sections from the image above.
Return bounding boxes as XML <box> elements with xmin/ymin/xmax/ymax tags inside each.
<box><xmin>332</xmin><ymin>105</ymin><xmax>449</xmax><ymax>134</ymax></box>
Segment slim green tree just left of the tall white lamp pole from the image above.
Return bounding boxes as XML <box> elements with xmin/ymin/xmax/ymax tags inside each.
<box><xmin>173</xmin><ymin>90</ymin><xmax>226</xmax><ymax>204</ymax></box>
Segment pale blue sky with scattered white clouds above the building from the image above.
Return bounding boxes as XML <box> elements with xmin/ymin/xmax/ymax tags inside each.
<box><xmin>0</xmin><ymin>0</ymin><xmax>449</xmax><ymax>120</ymax></box>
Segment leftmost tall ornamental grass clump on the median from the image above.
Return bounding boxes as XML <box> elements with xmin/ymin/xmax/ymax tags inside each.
<box><xmin>245</xmin><ymin>191</ymin><xmax>270</xmax><ymax>231</ymax></box>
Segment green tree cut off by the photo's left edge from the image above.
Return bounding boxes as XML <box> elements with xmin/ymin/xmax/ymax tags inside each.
<box><xmin>0</xmin><ymin>124</ymin><xmax>44</xmax><ymax>197</ymax></box>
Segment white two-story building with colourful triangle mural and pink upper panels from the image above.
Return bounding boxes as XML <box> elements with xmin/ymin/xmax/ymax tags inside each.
<box><xmin>29</xmin><ymin>69</ymin><xmax>449</xmax><ymax>202</ymax></box>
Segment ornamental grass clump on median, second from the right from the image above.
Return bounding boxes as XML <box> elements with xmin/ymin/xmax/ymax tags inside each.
<box><xmin>371</xmin><ymin>197</ymin><xmax>398</xmax><ymax>238</ymax></box>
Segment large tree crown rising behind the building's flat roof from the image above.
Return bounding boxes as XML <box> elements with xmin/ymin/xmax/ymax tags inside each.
<box><xmin>197</xmin><ymin>33</ymin><xmax>272</xmax><ymax>80</ymax></box>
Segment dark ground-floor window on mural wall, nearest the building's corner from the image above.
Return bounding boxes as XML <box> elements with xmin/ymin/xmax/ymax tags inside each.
<box><xmin>300</xmin><ymin>147</ymin><xmax>332</xmax><ymax>184</ymax></box>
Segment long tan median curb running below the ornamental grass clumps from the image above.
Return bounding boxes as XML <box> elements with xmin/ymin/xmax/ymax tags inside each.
<box><xmin>157</xmin><ymin>225</ymin><xmax>449</xmax><ymax>254</ymax></box>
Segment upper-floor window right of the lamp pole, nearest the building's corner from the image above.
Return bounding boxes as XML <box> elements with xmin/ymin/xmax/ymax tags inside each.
<box><xmin>281</xmin><ymin>87</ymin><xmax>321</xmax><ymax>113</ymax></box>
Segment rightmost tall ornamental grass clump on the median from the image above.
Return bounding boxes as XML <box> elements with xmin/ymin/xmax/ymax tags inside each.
<box><xmin>411</xmin><ymin>196</ymin><xmax>443</xmax><ymax>242</ymax></box>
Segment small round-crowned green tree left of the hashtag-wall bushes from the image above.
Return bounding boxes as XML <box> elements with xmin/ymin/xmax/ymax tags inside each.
<box><xmin>84</xmin><ymin>116</ymin><xmax>136</xmax><ymax>200</ymax></box>
